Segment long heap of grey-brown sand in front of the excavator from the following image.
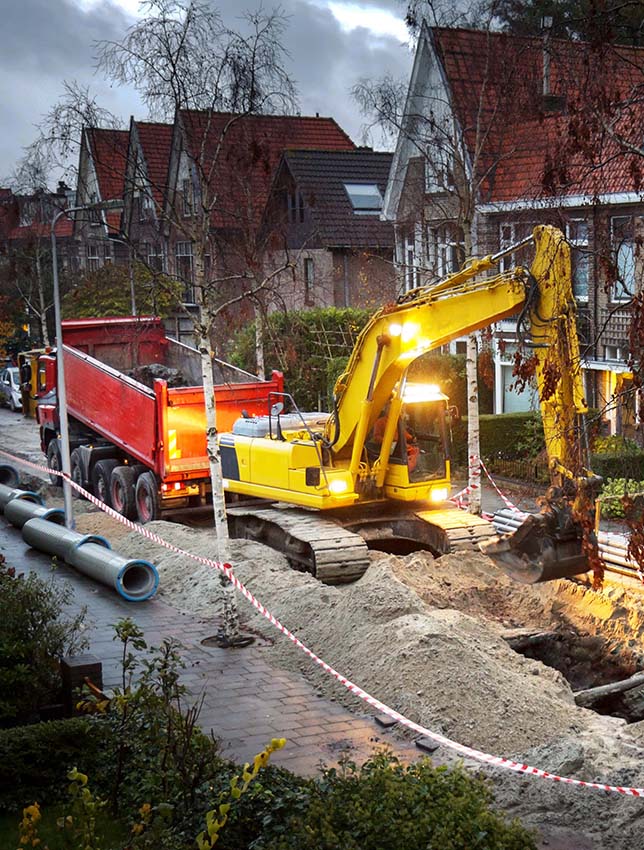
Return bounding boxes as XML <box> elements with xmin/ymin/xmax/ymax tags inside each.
<box><xmin>78</xmin><ymin>513</ymin><xmax>644</xmax><ymax>850</ymax></box>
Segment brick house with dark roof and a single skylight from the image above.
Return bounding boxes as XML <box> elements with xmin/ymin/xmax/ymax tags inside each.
<box><xmin>265</xmin><ymin>148</ymin><xmax>395</xmax><ymax>309</ymax></box>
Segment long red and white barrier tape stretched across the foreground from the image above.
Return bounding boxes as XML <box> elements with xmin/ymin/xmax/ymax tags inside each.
<box><xmin>0</xmin><ymin>449</ymin><xmax>644</xmax><ymax>797</ymax></box>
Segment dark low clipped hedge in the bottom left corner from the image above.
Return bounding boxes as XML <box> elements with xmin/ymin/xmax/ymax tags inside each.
<box><xmin>0</xmin><ymin>717</ymin><xmax>111</xmax><ymax>812</ymax></box>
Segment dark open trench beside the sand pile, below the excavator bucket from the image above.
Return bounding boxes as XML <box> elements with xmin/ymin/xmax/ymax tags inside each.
<box><xmin>509</xmin><ymin>627</ymin><xmax>644</xmax><ymax>723</ymax></box>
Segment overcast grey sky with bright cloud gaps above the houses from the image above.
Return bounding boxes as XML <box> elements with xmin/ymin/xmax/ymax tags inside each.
<box><xmin>0</xmin><ymin>0</ymin><xmax>412</xmax><ymax>183</ymax></box>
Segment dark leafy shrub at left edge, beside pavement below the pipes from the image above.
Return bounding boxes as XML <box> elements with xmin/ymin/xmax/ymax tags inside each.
<box><xmin>0</xmin><ymin>556</ymin><xmax>87</xmax><ymax>725</ymax></box>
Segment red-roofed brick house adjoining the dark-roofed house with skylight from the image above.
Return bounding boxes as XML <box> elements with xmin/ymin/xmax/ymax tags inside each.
<box><xmin>158</xmin><ymin>110</ymin><xmax>355</xmax><ymax>339</ymax></box>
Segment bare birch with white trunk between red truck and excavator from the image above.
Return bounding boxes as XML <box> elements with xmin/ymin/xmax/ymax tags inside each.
<box><xmin>98</xmin><ymin>0</ymin><xmax>295</xmax><ymax>641</ymax></box>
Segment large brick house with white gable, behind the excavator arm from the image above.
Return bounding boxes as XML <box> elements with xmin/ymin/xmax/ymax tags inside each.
<box><xmin>384</xmin><ymin>25</ymin><xmax>644</xmax><ymax>433</ymax></box>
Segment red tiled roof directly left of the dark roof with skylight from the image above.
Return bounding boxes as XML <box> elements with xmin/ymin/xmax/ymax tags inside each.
<box><xmin>180</xmin><ymin>110</ymin><xmax>355</xmax><ymax>227</ymax></box>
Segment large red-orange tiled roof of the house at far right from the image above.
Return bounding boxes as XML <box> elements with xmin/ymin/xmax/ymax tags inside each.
<box><xmin>432</xmin><ymin>28</ymin><xmax>644</xmax><ymax>202</ymax></box>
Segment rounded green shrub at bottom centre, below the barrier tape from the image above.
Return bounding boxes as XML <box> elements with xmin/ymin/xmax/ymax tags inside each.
<box><xmin>253</xmin><ymin>754</ymin><xmax>536</xmax><ymax>850</ymax></box>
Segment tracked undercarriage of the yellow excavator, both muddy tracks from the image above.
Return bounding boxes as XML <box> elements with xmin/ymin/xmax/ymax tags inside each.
<box><xmin>227</xmin><ymin>505</ymin><xmax>496</xmax><ymax>584</ymax></box>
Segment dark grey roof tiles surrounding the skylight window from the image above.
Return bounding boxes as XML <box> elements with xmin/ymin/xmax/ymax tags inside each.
<box><xmin>284</xmin><ymin>148</ymin><xmax>394</xmax><ymax>248</ymax></box>
